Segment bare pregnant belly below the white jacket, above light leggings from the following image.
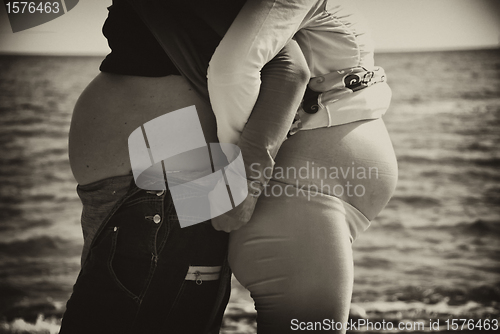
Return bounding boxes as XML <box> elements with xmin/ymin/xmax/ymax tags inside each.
<box><xmin>274</xmin><ymin>119</ymin><xmax>398</xmax><ymax>220</ymax></box>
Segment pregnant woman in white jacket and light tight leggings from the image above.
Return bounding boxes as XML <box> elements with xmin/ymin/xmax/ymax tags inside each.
<box><xmin>203</xmin><ymin>0</ymin><xmax>397</xmax><ymax>334</ymax></box>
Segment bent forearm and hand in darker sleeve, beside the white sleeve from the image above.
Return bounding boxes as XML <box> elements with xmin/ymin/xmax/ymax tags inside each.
<box><xmin>212</xmin><ymin>40</ymin><xmax>309</xmax><ymax>232</ymax></box>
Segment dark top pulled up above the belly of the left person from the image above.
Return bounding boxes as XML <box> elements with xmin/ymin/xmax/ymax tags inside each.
<box><xmin>100</xmin><ymin>0</ymin><xmax>245</xmax><ymax>83</ymax></box>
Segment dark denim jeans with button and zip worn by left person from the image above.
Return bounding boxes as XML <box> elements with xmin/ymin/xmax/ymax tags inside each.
<box><xmin>60</xmin><ymin>177</ymin><xmax>231</xmax><ymax>334</ymax></box>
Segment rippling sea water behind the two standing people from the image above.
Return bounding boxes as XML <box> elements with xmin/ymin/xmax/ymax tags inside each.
<box><xmin>0</xmin><ymin>50</ymin><xmax>500</xmax><ymax>333</ymax></box>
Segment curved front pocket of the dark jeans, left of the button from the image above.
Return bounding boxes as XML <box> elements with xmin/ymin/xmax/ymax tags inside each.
<box><xmin>108</xmin><ymin>226</ymin><xmax>155</xmax><ymax>302</ymax></box>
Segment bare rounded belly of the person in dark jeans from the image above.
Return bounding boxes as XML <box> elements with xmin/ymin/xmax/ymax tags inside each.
<box><xmin>69</xmin><ymin>73</ymin><xmax>217</xmax><ymax>185</ymax></box>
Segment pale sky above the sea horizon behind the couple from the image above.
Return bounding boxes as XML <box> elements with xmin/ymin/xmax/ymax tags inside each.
<box><xmin>0</xmin><ymin>0</ymin><xmax>500</xmax><ymax>55</ymax></box>
